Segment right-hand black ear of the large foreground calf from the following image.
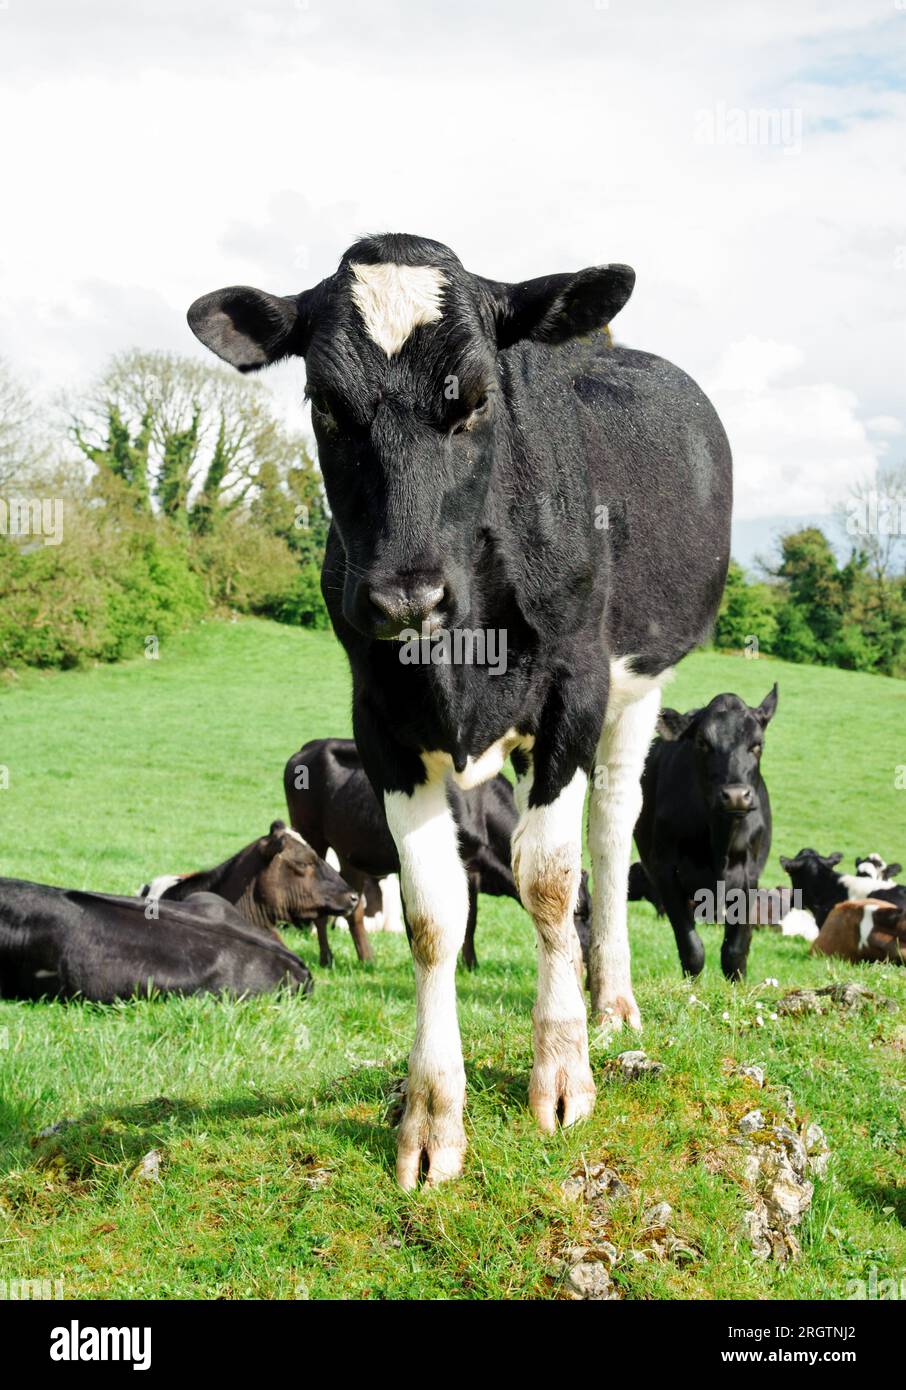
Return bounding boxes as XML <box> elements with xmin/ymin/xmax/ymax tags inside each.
<box><xmin>485</xmin><ymin>265</ymin><xmax>635</xmax><ymax>348</ymax></box>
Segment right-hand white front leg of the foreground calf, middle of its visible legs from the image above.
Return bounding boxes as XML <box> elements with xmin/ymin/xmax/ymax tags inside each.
<box><xmin>513</xmin><ymin>771</ymin><xmax>595</xmax><ymax>1133</ymax></box>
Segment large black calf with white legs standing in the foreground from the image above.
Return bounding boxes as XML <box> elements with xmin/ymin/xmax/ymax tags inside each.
<box><xmin>189</xmin><ymin>227</ymin><xmax>731</xmax><ymax>1187</ymax></box>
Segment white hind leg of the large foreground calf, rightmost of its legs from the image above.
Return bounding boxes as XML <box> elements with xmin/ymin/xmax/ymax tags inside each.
<box><xmin>588</xmin><ymin>688</ymin><xmax>660</xmax><ymax>1033</ymax></box>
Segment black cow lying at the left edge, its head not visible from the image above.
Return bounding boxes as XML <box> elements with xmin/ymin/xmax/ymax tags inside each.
<box><xmin>0</xmin><ymin>878</ymin><xmax>313</xmax><ymax>1004</ymax></box>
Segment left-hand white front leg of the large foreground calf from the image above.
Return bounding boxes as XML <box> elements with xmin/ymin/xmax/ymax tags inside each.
<box><xmin>384</xmin><ymin>777</ymin><xmax>468</xmax><ymax>1188</ymax></box>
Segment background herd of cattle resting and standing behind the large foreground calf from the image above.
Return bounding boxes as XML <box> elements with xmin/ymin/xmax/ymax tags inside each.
<box><xmin>0</xmin><ymin>687</ymin><xmax>906</xmax><ymax>1002</ymax></box>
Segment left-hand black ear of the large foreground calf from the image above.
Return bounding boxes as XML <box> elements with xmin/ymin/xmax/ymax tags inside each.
<box><xmin>188</xmin><ymin>285</ymin><xmax>313</xmax><ymax>371</ymax></box>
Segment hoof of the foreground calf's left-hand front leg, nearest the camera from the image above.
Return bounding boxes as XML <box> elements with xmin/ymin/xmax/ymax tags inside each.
<box><xmin>396</xmin><ymin>1076</ymin><xmax>466</xmax><ymax>1191</ymax></box>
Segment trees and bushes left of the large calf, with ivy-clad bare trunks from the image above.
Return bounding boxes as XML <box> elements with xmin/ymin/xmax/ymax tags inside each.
<box><xmin>0</xmin><ymin>352</ymin><xmax>329</xmax><ymax>669</ymax></box>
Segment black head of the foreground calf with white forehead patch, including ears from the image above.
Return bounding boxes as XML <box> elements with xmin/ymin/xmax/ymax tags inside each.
<box><xmin>189</xmin><ymin>235</ymin><xmax>635</xmax><ymax>638</ymax></box>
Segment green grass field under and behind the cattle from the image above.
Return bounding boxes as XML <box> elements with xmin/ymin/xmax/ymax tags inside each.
<box><xmin>0</xmin><ymin>621</ymin><xmax>906</xmax><ymax>1298</ymax></box>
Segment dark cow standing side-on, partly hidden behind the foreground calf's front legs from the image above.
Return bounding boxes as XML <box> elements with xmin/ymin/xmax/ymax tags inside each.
<box><xmin>283</xmin><ymin>738</ymin><xmax>591</xmax><ymax>970</ymax></box>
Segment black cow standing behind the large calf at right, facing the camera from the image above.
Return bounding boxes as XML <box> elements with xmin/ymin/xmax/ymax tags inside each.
<box><xmin>629</xmin><ymin>685</ymin><xmax>777</xmax><ymax>980</ymax></box>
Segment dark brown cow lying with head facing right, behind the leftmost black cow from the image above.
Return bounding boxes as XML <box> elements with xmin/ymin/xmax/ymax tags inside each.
<box><xmin>142</xmin><ymin>820</ymin><xmax>358</xmax><ymax>955</ymax></box>
